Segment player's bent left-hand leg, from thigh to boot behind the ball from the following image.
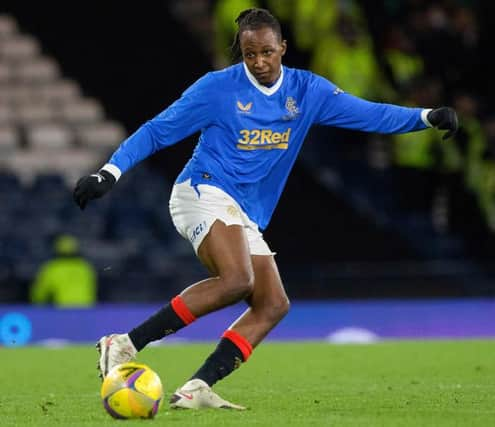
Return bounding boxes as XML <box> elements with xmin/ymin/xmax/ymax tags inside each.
<box><xmin>98</xmin><ymin>220</ymin><xmax>254</xmax><ymax>376</ymax></box>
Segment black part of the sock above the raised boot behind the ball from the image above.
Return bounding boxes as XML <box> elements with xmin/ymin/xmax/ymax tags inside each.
<box><xmin>129</xmin><ymin>304</ymin><xmax>186</xmax><ymax>351</ymax></box>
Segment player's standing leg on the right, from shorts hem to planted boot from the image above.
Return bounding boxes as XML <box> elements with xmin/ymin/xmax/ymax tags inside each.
<box><xmin>170</xmin><ymin>255</ymin><xmax>289</xmax><ymax>409</ymax></box>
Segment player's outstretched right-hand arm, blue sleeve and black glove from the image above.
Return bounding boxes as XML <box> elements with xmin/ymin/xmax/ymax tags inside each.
<box><xmin>313</xmin><ymin>77</ymin><xmax>458</xmax><ymax>138</ymax></box>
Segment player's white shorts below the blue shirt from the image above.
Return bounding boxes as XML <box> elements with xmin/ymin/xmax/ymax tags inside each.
<box><xmin>169</xmin><ymin>180</ymin><xmax>275</xmax><ymax>255</ymax></box>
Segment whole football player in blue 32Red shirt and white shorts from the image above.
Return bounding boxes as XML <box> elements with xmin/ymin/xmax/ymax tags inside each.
<box><xmin>74</xmin><ymin>8</ymin><xmax>458</xmax><ymax>409</ymax></box>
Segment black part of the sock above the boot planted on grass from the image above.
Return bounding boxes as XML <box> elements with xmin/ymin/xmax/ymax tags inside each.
<box><xmin>191</xmin><ymin>338</ymin><xmax>244</xmax><ymax>387</ymax></box>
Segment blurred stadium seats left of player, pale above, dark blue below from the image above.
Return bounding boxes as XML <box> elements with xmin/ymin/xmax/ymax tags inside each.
<box><xmin>0</xmin><ymin>15</ymin><xmax>203</xmax><ymax>302</ymax></box>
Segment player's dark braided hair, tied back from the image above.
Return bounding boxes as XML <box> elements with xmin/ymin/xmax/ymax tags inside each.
<box><xmin>230</xmin><ymin>7</ymin><xmax>282</xmax><ymax>63</ymax></box>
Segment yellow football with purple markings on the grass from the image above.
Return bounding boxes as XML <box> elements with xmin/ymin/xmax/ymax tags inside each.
<box><xmin>101</xmin><ymin>362</ymin><xmax>163</xmax><ymax>419</ymax></box>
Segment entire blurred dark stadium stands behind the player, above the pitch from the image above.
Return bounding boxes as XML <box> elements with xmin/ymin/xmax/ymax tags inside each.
<box><xmin>0</xmin><ymin>0</ymin><xmax>495</xmax><ymax>346</ymax></box>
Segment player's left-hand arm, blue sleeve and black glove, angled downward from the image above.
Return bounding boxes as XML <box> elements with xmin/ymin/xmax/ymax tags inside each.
<box><xmin>73</xmin><ymin>74</ymin><xmax>215</xmax><ymax>209</ymax></box>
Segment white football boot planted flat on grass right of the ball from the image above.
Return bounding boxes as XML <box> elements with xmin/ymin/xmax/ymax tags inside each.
<box><xmin>170</xmin><ymin>378</ymin><xmax>246</xmax><ymax>411</ymax></box>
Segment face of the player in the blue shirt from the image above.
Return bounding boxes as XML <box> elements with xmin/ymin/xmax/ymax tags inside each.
<box><xmin>239</xmin><ymin>27</ymin><xmax>287</xmax><ymax>85</ymax></box>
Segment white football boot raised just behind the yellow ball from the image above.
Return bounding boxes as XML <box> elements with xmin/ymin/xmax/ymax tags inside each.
<box><xmin>96</xmin><ymin>334</ymin><xmax>137</xmax><ymax>380</ymax></box>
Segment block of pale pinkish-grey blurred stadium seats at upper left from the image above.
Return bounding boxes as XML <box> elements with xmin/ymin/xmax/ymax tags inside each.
<box><xmin>0</xmin><ymin>15</ymin><xmax>126</xmax><ymax>184</ymax></box>
